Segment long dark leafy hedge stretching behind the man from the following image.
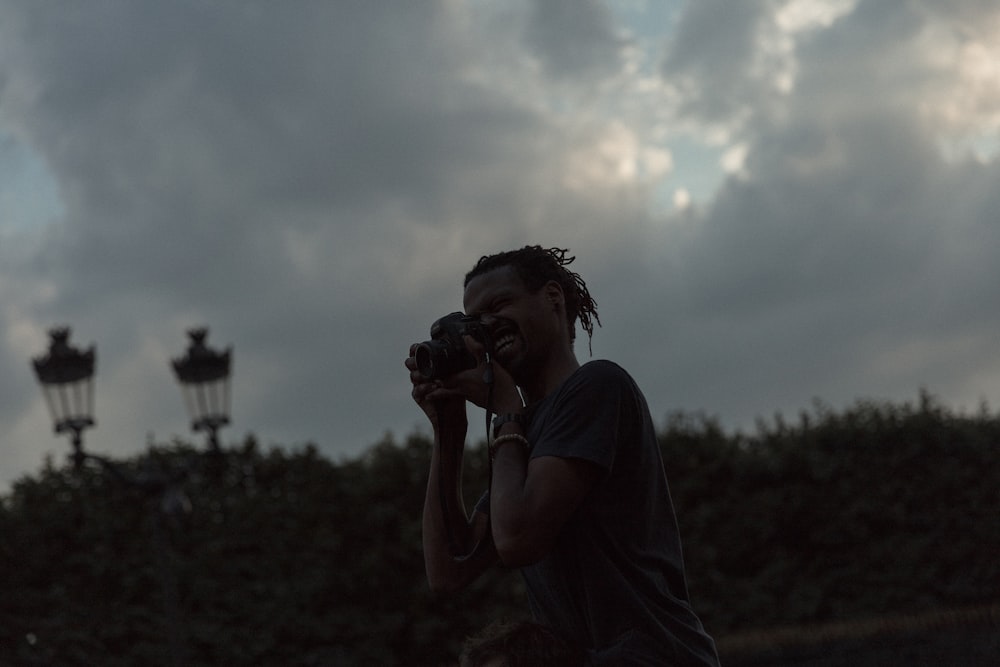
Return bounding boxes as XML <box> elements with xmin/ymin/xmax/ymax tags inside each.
<box><xmin>0</xmin><ymin>395</ymin><xmax>1000</xmax><ymax>666</ymax></box>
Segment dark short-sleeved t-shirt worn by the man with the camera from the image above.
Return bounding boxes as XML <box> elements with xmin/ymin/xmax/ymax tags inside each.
<box><xmin>522</xmin><ymin>361</ymin><xmax>718</xmax><ymax>666</ymax></box>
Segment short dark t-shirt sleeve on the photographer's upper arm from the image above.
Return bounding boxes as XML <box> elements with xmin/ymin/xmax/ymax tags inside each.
<box><xmin>531</xmin><ymin>362</ymin><xmax>630</xmax><ymax>470</ymax></box>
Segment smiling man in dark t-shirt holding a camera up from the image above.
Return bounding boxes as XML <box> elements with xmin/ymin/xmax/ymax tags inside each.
<box><xmin>406</xmin><ymin>246</ymin><xmax>718</xmax><ymax>666</ymax></box>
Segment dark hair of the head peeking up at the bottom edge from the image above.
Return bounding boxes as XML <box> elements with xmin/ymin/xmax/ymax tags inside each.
<box><xmin>459</xmin><ymin>621</ymin><xmax>585</xmax><ymax>667</ymax></box>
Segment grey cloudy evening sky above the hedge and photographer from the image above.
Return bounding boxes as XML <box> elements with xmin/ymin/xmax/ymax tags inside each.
<box><xmin>0</xmin><ymin>0</ymin><xmax>1000</xmax><ymax>485</ymax></box>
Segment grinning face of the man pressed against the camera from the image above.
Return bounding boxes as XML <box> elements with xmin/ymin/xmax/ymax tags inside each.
<box><xmin>464</xmin><ymin>266</ymin><xmax>566</xmax><ymax>381</ymax></box>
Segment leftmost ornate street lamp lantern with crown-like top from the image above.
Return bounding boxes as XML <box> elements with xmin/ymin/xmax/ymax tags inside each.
<box><xmin>32</xmin><ymin>327</ymin><xmax>97</xmax><ymax>468</ymax></box>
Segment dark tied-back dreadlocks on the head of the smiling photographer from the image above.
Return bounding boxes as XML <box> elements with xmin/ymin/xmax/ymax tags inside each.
<box><xmin>465</xmin><ymin>245</ymin><xmax>601</xmax><ymax>350</ymax></box>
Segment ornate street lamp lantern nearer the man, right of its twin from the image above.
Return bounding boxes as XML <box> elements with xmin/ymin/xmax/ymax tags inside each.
<box><xmin>171</xmin><ymin>328</ymin><xmax>232</xmax><ymax>452</ymax></box>
